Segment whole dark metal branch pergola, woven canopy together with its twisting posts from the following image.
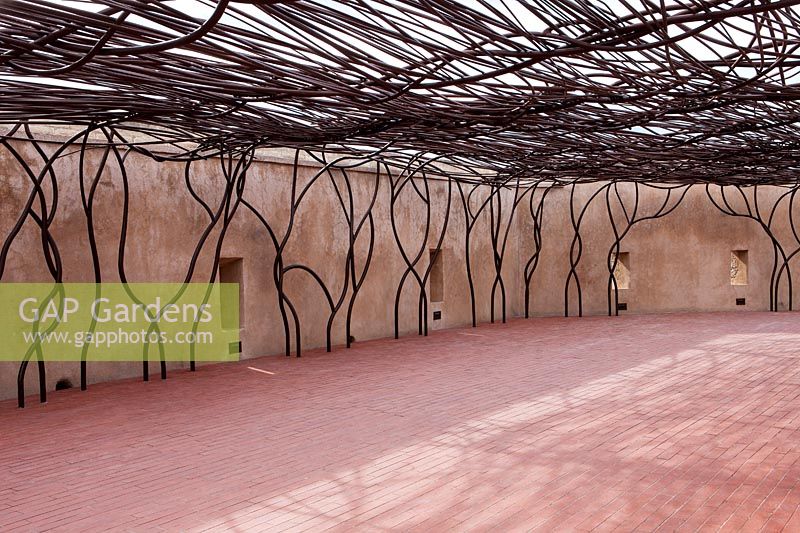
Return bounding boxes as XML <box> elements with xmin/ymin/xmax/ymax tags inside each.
<box><xmin>6</xmin><ymin>0</ymin><xmax>800</xmax><ymax>405</ymax></box>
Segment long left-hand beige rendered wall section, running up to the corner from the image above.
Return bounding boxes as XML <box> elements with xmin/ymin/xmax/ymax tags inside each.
<box><xmin>0</xmin><ymin>143</ymin><xmax>522</xmax><ymax>398</ymax></box>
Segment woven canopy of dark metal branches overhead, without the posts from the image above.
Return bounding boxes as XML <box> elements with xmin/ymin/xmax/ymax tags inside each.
<box><xmin>0</xmin><ymin>0</ymin><xmax>800</xmax><ymax>184</ymax></box>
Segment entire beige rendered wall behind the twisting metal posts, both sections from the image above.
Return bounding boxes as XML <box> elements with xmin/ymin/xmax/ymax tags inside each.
<box><xmin>0</xmin><ymin>137</ymin><xmax>798</xmax><ymax>398</ymax></box>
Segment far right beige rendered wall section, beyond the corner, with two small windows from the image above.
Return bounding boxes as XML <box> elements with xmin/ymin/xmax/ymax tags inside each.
<box><xmin>522</xmin><ymin>183</ymin><xmax>800</xmax><ymax>315</ymax></box>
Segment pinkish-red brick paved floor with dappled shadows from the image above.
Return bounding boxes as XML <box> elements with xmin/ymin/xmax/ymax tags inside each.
<box><xmin>0</xmin><ymin>313</ymin><xmax>800</xmax><ymax>532</ymax></box>
